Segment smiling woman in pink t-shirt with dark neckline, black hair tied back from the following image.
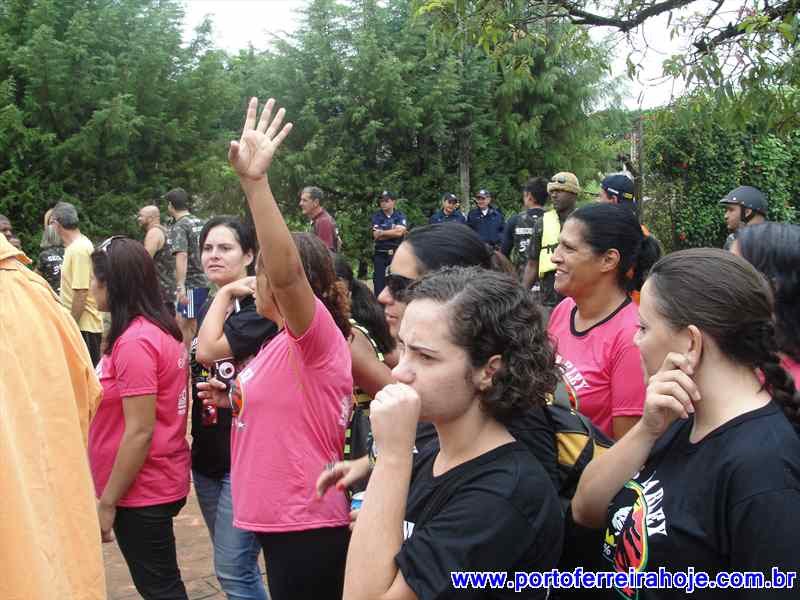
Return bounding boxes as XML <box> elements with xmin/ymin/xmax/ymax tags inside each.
<box><xmin>548</xmin><ymin>203</ymin><xmax>656</xmax><ymax>439</ymax></box>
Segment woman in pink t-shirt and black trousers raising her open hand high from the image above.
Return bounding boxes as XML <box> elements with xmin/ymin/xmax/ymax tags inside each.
<box><xmin>198</xmin><ymin>98</ymin><xmax>353</xmax><ymax>600</ymax></box>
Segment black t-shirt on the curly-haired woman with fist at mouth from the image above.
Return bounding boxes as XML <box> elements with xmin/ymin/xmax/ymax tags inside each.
<box><xmin>395</xmin><ymin>442</ymin><xmax>564</xmax><ymax>600</ymax></box>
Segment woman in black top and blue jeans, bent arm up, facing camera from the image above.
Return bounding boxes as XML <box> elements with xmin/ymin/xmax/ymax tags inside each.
<box><xmin>191</xmin><ymin>216</ymin><xmax>278</xmax><ymax>600</ymax></box>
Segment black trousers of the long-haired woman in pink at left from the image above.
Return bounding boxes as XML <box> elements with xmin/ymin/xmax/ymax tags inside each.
<box><xmin>114</xmin><ymin>498</ymin><xmax>189</xmax><ymax>600</ymax></box>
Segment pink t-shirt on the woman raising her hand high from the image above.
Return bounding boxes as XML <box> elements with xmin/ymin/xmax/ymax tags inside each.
<box><xmin>231</xmin><ymin>299</ymin><xmax>353</xmax><ymax>532</ymax></box>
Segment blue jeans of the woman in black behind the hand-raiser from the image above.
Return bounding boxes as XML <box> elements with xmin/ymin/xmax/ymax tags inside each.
<box><xmin>192</xmin><ymin>471</ymin><xmax>269</xmax><ymax>600</ymax></box>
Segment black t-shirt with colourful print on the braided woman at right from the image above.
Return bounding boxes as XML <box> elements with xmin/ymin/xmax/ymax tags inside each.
<box><xmin>602</xmin><ymin>403</ymin><xmax>800</xmax><ymax>600</ymax></box>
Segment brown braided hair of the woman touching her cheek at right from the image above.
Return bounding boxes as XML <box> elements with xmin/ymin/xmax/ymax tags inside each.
<box><xmin>648</xmin><ymin>248</ymin><xmax>800</xmax><ymax>428</ymax></box>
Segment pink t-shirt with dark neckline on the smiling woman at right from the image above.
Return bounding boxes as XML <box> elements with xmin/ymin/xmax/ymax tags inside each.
<box><xmin>547</xmin><ymin>298</ymin><xmax>645</xmax><ymax>437</ymax></box>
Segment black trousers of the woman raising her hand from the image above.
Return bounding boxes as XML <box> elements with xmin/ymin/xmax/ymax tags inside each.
<box><xmin>256</xmin><ymin>527</ymin><xmax>350</xmax><ymax>600</ymax></box>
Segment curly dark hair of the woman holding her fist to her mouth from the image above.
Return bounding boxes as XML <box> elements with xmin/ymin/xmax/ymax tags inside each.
<box><xmin>408</xmin><ymin>267</ymin><xmax>558</xmax><ymax>424</ymax></box>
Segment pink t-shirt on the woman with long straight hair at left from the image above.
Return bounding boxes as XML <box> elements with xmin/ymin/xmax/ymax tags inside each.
<box><xmin>89</xmin><ymin>317</ymin><xmax>191</xmax><ymax>507</ymax></box>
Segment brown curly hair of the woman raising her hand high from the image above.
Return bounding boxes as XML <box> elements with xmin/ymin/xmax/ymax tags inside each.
<box><xmin>292</xmin><ymin>233</ymin><xmax>350</xmax><ymax>339</ymax></box>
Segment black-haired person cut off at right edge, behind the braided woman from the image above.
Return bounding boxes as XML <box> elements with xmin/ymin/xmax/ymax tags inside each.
<box><xmin>731</xmin><ymin>223</ymin><xmax>800</xmax><ymax>389</ymax></box>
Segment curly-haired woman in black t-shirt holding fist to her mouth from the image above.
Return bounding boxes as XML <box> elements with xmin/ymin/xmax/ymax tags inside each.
<box><xmin>345</xmin><ymin>267</ymin><xmax>563</xmax><ymax>600</ymax></box>
